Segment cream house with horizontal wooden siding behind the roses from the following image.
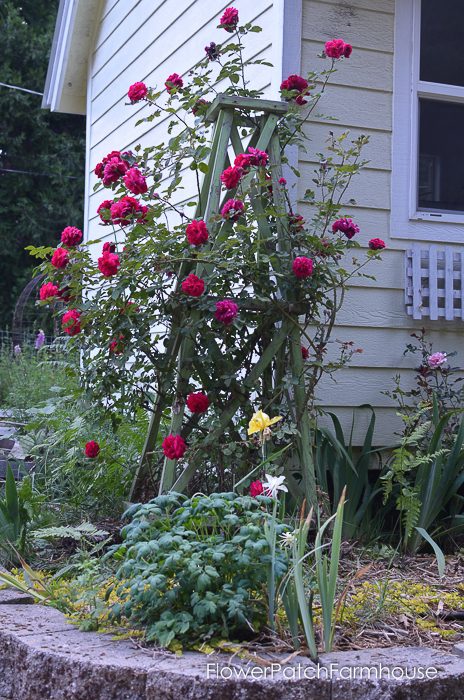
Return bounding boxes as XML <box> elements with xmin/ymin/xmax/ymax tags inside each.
<box><xmin>44</xmin><ymin>0</ymin><xmax>464</xmax><ymax>445</ymax></box>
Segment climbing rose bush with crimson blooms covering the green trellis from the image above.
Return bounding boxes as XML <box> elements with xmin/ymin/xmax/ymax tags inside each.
<box><xmin>32</xmin><ymin>7</ymin><xmax>385</xmax><ymax>490</ymax></box>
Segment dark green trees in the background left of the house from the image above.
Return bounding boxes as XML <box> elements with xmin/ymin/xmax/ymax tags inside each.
<box><xmin>0</xmin><ymin>0</ymin><xmax>85</xmax><ymax>328</ymax></box>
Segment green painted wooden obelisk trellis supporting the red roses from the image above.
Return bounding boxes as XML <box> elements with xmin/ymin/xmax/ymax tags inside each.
<box><xmin>131</xmin><ymin>95</ymin><xmax>316</xmax><ymax>503</ymax></box>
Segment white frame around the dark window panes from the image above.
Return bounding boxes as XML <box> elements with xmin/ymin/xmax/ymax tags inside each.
<box><xmin>390</xmin><ymin>0</ymin><xmax>464</xmax><ymax>243</ymax></box>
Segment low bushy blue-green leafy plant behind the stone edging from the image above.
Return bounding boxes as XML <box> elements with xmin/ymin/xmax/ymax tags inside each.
<box><xmin>113</xmin><ymin>493</ymin><xmax>286</xmax><ymax>646</ymax></box>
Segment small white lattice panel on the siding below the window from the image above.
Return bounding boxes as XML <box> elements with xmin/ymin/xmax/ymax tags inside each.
<box><xmin>405</xmin><ymin>245</ymin><xmax>464</xmax><ymax>321</ymax></box>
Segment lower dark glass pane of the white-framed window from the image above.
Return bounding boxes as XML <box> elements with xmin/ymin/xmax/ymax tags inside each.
<box><xmin>418</xmin><ymin>100</ymin><xmax>464</xmax><ymax>211</ymax></box>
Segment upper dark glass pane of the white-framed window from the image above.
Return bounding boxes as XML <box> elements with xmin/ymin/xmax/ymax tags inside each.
<box><xmin>420</xmin><ymin>0</ymin><xmax>464</xmax><ymax>86</ymax></box>
